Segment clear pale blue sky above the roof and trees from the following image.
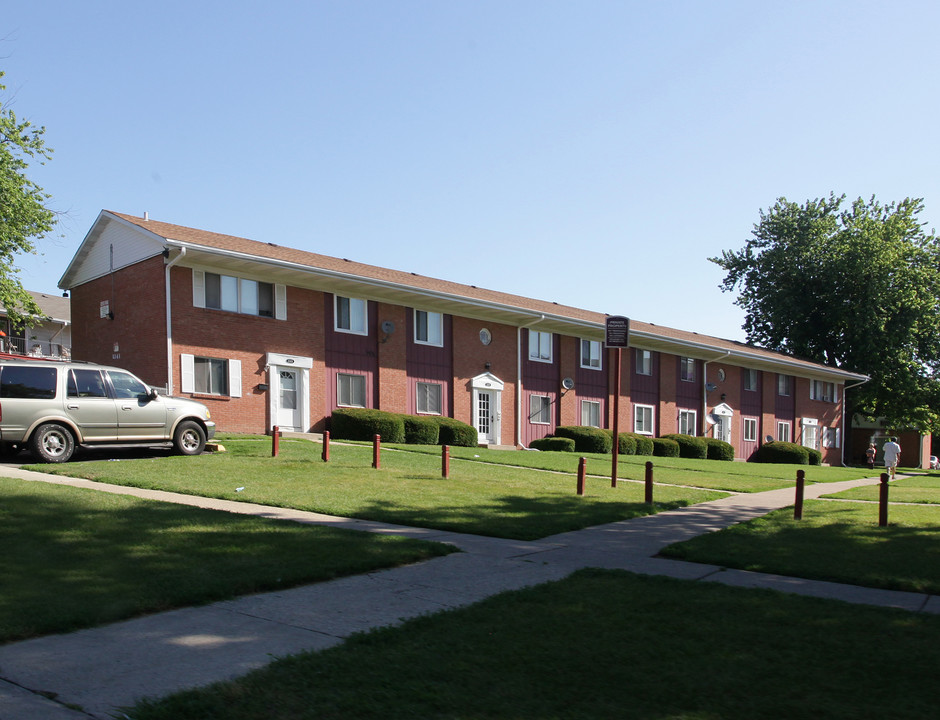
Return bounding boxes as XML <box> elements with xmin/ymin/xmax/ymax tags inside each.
<box><xmin>0</xmin><ymin>0</ymin><xmax>940</xmax><ymax>340</ymax></box>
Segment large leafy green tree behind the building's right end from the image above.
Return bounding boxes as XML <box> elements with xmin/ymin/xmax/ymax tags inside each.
<box><xmin>709</xmin><ymin>194</ymin><xmax>940</xmax><ymax>432</ymax></box>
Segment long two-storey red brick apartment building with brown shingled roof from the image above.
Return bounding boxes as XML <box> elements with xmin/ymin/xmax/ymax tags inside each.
<box><xmin>59</xmin><ymin>211</ymin><xmax>867</xmax><ymax>464</ymax></box>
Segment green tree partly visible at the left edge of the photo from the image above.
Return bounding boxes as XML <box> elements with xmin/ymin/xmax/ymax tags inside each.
<box><xmin>0</xmin><ymin>71</ymin><xmax>56</xmax><ymax>327</ymax></box>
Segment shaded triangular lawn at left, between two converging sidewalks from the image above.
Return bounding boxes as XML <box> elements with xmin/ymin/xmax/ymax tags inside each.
<box><xmin>0</xmin><ymin>478</ymin><xmax>453</xmax><ymax>642</ymax></box>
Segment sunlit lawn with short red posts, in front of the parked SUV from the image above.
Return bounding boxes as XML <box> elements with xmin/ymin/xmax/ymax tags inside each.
<box><xmin>30</xmin><ymin>439</ymin><xmax>730</xmax><ymax>540</ymax></box>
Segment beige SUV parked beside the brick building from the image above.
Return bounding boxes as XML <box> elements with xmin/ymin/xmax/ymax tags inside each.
<box><xmin>0</xmin><ymin>358</ymin><xmax>215</xmax><ymax>463</ymax></box>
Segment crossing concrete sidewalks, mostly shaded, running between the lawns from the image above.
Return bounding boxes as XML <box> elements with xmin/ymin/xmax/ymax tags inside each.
<box><xmin>0</xmin><ymin>469</ymin><xmax>940</xmax><ymax>720</ymax></box>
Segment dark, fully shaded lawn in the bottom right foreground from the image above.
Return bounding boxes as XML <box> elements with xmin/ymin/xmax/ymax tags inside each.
<box><xmin>127</xmin><ymin>570</ymin><xmax>940</xmax><ymax>720</ymax></box>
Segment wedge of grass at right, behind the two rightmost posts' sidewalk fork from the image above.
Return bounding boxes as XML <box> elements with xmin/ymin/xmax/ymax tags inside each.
<box><xmin>661</xmin><ymin>498</ymin><xmax>940</xmax><ymax>594</ymax></box>
